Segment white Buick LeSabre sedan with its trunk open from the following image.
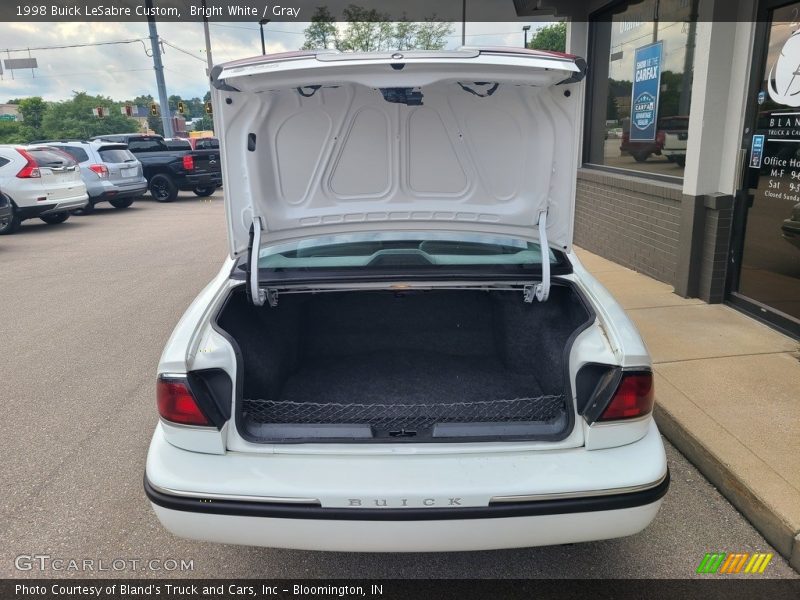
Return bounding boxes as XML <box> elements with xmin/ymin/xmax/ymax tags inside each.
<box><xmin>145</xmin><ymin>48</ymin><xmax>669</xmax><ymax>551</ymax></box>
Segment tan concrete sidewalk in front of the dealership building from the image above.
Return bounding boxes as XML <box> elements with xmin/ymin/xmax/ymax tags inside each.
<box><xmin>576</xmin><ymin>249</ymin><xmax>800</xmax><ymax>571</ymax></box>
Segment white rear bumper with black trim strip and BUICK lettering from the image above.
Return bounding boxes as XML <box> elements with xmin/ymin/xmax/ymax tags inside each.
<box><xmin>144</xmin><ymin>424</ymin><xmax>669</xmax><ymax>552</ymax></box>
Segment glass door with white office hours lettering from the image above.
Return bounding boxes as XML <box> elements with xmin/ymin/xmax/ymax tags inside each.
<box><xmin>728</xmin><ymin>0</ymin><xmax>800</xmax><ymax>337</ymax></box>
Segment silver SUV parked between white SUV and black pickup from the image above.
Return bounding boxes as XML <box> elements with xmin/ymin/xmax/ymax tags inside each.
<box><xmin>31</xmin><ymin>140</ymin><xmax>147</xmax><ymax>212</ymax></box>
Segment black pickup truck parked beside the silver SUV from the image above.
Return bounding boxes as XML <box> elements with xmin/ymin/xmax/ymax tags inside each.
<box><xmin>92</xmin><ymin>133</ymin><xmax>222</xmax><ymax>202</ymax></box>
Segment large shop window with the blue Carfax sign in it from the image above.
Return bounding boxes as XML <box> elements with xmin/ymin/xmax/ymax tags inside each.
<box><xmin>584</xmin><ymin>0</ymin><xmax>699</xmax><ymax>178</ymax></box>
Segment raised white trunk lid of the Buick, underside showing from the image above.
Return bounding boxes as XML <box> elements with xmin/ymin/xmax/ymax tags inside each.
<box><xmin>212</xmin><ymin>48</ymin><xmax>585</xmax><ymax>256</ymax></box>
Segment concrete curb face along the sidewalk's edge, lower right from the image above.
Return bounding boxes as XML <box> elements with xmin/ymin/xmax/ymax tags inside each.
<box><xmin>653</xmin><ymin>404</ymin><xmax>800</xmax><ymax>573</ymax></box>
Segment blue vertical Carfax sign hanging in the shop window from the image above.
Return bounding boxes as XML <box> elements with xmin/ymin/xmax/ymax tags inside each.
<box><xmin>630</xmin><ymin>42</ymin><xmax>662</xmax><ymax>142</ymax></box>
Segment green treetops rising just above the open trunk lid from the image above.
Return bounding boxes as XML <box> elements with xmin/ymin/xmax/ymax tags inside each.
<box><xmin>303</xmin><ymin>4</ymin><xmax>453</xmax><ymax>52</ymax></box>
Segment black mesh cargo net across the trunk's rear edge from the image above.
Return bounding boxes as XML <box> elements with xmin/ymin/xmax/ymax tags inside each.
<box><xmin>242</xmin><ymin>395</ymin><xmax>566</xmax><ymax>431</ymax></box>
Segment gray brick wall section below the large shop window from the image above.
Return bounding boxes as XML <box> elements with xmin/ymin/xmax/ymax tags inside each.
<box><xmin>575</xmin><ymin>169</ymin><xmax>683</xmax><ymax>286</ymax></box>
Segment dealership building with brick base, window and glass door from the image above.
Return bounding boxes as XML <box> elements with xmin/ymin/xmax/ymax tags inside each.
<box><xmin>514</xmin><ymin>0</ymin><xmax>800</xmax><ymax>337</ymax></box>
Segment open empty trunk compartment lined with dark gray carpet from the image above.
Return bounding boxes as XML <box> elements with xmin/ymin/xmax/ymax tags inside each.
<box><xmin>217</xmin><ymin>284</ymin><xmax>593</xmax><ymax>443</ymax></box>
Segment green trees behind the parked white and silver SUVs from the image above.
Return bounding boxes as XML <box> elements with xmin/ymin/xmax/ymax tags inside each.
<box><xmin>41</xmin><ymin>92</ymin><xmax>138</xmax><ymax>139</ymax></box>
